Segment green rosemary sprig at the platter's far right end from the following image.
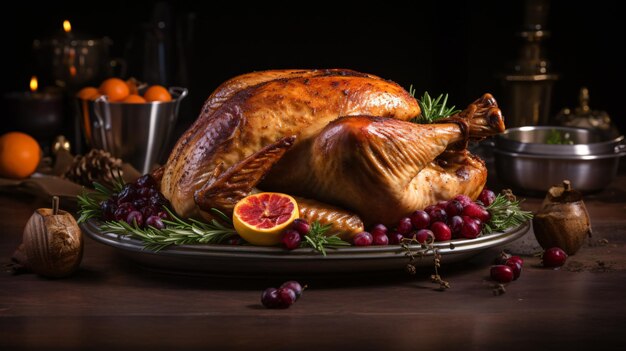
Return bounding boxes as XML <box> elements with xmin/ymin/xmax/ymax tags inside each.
<box><xmin>483</xmin><ymin>191</ymin><xmax>533</xmax><ymax>234</ymax></box>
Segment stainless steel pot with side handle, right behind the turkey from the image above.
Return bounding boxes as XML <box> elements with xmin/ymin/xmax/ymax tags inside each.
<box><xmin>493</xmin><ymin>126</ymin><xmax>626</xmax><ymax>193</ymax></box>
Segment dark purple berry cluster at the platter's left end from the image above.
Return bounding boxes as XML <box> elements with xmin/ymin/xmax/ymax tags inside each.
<box><xmin>100</xmin><ymin>174</ymin><xmax>169</xmax><ymax>229</ymax></box>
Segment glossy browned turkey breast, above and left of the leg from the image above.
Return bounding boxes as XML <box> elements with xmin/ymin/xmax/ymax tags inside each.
<box><xmin>161</xmin><ymin>70</ymin><xmax>420</xmax><ymax>217</ymax></box>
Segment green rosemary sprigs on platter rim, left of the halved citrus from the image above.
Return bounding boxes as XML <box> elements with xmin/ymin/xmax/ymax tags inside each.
<box><xmin>100</xmin><ymin>207</ymin><xmax>237</xmax><ymax>251</ymax></box>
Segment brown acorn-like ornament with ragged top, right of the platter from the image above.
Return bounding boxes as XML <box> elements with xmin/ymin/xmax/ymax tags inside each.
<box><xmin>533</xmin><ymin>180</ymin><xmax>591</xmax><ymax>255</ymax></box>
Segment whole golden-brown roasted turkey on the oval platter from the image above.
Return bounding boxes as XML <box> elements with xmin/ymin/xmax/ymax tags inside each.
<box><xmin>158</xmin><ymin>69</ymin><xmax>504</xmax><ymax>233</ymax></box>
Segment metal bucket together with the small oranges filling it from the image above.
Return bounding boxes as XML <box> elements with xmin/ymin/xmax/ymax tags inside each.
<box><xmin>76</xmin><ymin>78</ymin><xmax>188</xmax><ymax>174</ymax></box>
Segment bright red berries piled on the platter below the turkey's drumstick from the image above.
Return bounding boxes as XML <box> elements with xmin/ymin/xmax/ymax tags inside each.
<box><xmin>353</xmin><ymin>189</ymin><xmax>496</xmax><ymax>246</ymax></box>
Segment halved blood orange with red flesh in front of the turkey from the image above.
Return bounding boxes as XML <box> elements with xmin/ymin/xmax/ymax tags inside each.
<box><xmin>233</xmin><ymin>193</ymin><xmax>300</xmax><ymax>246</ymax></box>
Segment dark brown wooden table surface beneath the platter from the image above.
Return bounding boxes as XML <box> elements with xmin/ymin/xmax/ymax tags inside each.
<box><xmin>0</xmin><ymin>171</ymin><xmax>626</xmax><ymax>350</ymax></box>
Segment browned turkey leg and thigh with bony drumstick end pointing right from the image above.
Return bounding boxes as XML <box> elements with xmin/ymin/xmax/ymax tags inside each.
<box><xmin>260</xmin><ymin>94</ymin><xmax>504</xmax><ymax>225</ymax></box>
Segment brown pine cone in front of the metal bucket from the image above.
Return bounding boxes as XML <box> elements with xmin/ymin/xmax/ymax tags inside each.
<box><xmin>63</xmin><ymin>149</ymin><xmax>122</xmax><ymax>188</ymax></box>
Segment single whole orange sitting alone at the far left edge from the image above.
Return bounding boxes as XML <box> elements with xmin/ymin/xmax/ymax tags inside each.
<box><xmin>0</xmin><ymin>132</ymin><xmax>41</xmax><ymax>179</ymax></box>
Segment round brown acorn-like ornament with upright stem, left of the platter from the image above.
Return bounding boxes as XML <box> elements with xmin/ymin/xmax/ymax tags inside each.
<box><xmin>13</xmin><ymin>196</ymin><xmax>83</xmax><ymax>278</ymax></box>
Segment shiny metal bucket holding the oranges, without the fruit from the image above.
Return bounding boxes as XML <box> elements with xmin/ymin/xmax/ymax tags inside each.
<box><xmin>78</xmin><ymin>87</ymin><xmax>188</xmax><ymax>174</ymax></box>
